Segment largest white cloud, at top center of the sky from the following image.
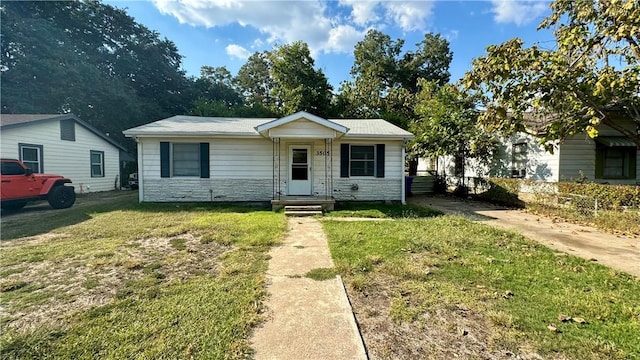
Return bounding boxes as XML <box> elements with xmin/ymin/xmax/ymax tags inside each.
<box><xmin>153</xmin><ymin>0</ymin><xmax>433</xmax><ymax>56</ymax></box>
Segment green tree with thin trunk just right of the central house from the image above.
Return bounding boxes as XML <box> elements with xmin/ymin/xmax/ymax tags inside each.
<box><xmin>409</xmin><ymin>79</ymin><xmax>497</xmax><ymax>181</ymax></box>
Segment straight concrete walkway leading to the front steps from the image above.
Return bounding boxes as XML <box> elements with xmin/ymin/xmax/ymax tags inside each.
<box><xmin>252</xmin><ymin>218</ymin><xmax>367</xmax><ymax>360</ymax></box>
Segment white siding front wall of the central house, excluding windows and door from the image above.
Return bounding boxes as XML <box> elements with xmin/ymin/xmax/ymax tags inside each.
<box><xmin>139</xmin><ymin>138</ymin><xmax>404</xmax><ymax>202</ymax></box>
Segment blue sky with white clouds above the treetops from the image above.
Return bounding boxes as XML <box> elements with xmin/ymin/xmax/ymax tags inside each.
<box><xmin>105</xmin><ymin>0</ymin><xmax>553</xmax><ymax>89</ymax></box>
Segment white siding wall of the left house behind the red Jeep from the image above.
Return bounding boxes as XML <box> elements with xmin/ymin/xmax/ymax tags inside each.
<box><xmin>1</xmin><ymin>121</ymin><xmax>120</xmax><ymax>193</ymax></box>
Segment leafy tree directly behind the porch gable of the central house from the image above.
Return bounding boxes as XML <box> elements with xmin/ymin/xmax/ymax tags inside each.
<box><xmin>269</xmin><ymin>41</ymin><xmax>332</xmax><ymax>117</ymax></box>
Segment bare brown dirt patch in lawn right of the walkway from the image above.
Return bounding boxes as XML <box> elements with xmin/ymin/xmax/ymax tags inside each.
<box><xmin>346</xmin><ymin>273</ymin><xmax>548</xmax><ymax>359</ymax></box>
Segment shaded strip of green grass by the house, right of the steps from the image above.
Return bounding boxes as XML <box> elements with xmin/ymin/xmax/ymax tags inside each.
<box><xmin>326</xmin><ymin>202</ymin><xmax>442</xmax><ymax>219</ymax></box>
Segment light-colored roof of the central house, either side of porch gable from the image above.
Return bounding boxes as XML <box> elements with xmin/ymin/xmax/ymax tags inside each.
<box><xmin>123</xmin><ymin>115</ymin><xmax>413</xmax><ymax>139</ymax></box>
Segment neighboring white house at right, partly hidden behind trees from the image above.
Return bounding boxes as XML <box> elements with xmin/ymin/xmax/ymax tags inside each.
<box><xmin>419</xmin><ymin>114</ymin><xmax>640</xmax><ymax>185</ymax></box>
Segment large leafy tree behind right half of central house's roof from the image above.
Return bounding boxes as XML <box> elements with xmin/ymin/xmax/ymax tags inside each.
<box><xmin>339</xmin><ymin>30</ymin><xmax>453</xmax><ymax>128</ymax></box>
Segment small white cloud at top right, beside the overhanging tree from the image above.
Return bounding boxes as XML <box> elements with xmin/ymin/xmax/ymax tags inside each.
<box><xmin>491</xmin><ymin>0</ymin><xmax>549</xmax><ymax>26</ymax></box>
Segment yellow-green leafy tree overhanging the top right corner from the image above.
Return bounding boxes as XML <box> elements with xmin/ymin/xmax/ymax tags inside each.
<box><xmin>462</xmin><ymin>0</ymin><xmax>640</xmax><ymax>147</ymax></box>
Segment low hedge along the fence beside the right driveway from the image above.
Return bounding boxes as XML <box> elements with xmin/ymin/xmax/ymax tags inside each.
<box><xmin>478</xmin><ymin>178</ymin><xmax>640</xmax><ymax>212</ymax></box>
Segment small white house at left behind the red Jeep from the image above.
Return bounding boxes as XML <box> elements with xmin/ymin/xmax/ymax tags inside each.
<box><xmin>0</xmin><ymin>114</ymin><xmax>131</xmax><ymax>193</ymax></box>
